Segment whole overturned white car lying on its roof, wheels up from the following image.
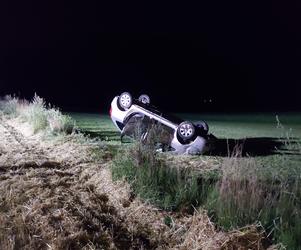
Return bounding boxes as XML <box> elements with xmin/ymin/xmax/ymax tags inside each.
<box><xmin>110</xmin><ymin>92</ymin><xmax>209</xmax><ymax>154</ymax></box>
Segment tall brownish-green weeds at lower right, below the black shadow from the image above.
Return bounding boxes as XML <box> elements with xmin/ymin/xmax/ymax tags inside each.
<box><xmin>206</xmin><ymin>145</ymin><xmax>301</xmax><ymax>249</ymax></box>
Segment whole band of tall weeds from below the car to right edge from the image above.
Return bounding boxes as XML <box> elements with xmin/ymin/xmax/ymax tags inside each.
<box><xmin>112</xmin><ymin>121</ymin><xmax>301</xmax><ymax>249</ymax></box>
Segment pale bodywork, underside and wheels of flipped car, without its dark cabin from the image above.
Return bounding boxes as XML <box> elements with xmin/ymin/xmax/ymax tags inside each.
<box><xmin>110</xmin><ymin>92</ymin><xmax>209</xmax><ymax>154</ymax></box>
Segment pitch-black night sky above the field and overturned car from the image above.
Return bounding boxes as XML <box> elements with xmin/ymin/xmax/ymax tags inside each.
<box><xmin>0</xmin><ymin>1</ymin><xmax>301</xmax><ymax>112</ymax></box>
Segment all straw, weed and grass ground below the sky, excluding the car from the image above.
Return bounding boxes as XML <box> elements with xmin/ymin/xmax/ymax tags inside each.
<box><xmin>0</xmin><ymin>96</ymin><xmax>301</xmax><ymax>250</ymax></box>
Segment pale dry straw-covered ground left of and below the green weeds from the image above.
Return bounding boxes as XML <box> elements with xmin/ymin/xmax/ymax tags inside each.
<box><xmin>0</xmin><ymin>119</ymin><xmax>264</xmax><ymax>249</ymax></box>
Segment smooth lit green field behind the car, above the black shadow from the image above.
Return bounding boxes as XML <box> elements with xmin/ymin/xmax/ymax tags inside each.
<box><xmin>70</xmin><ymin>113</ymin><xmax>301</xmax><ymax>141</ymax></box>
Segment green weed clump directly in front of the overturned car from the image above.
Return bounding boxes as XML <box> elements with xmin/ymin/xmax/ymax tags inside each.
<box><xmin>112</xmin><ymin>143</ymin><xmax>213</xmax><ymax>212</ymax></box>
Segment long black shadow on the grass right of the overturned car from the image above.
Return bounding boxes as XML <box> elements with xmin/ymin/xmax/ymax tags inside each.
<box><xmin>206</xmin><ymin>137</ymin><xmax>301</xmax><ymax>156</ymax></box>
